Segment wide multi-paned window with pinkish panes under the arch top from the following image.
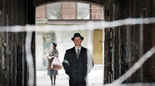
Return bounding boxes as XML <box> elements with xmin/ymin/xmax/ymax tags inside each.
<box><xmin>36</xmin><ymin>2</ymin><xmax>103</xmax><ymax>20</ymax></box>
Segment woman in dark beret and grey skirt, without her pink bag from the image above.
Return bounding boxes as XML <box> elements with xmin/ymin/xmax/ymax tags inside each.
<box><xmin>47</xmin><ymin>42</ymin><xmax>58</xmax><ymax>85</ymax></box>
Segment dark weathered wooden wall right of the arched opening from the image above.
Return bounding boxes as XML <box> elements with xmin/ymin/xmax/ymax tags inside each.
<box><xmin>104</xmin><ymin>0</ymin><xmax>155</xmax><ymax>83</ymax></box>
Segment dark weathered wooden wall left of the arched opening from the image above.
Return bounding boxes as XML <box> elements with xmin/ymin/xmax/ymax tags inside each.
<box><xmin>0</xmin><ymin>0</ymin><xmax>35</xmax><ymax>86</ymax></box>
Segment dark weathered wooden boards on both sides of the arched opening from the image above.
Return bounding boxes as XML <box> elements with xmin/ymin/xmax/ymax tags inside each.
<box><xmin>0</xmin><ymin>0</ymin><xmax>155</xmax><ymax>86</ymax></box>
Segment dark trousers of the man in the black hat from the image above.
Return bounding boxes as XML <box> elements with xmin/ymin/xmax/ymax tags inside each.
<box><xmin>69</xmin><ymin>78</ymin><xmax>86</xmax><ymax>86</ymax></box>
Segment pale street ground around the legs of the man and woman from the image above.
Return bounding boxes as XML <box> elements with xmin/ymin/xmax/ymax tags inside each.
<box><xmin>37</xmin><ymin>65</ymin><xmax>103</xmax><ymax>86</ymax></box>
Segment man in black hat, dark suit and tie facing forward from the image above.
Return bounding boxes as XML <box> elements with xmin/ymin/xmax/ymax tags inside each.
<box><xmin>63</xmin><ymin>33</ymin><xmax>94</xmax><ymax>86</ymax></box>
